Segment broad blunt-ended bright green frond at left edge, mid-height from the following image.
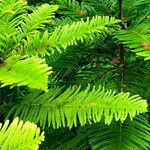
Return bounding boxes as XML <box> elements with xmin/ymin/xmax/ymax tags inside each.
<box><xmin>0</xmin><ymin>56</ymin><xmax>51</xmax><ymax>90</ymax></box>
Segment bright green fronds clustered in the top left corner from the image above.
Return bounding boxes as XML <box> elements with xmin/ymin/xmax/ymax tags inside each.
<box><xmin>0</xmin><ymin>0</ymin><xmax>58</xmax><ymax>57</ymax></box>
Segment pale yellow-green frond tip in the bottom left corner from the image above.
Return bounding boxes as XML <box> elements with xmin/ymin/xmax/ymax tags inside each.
<box><xmin>0</xmin><ymin>118</ymin><xmax>44</xmax><ymax>150</ymax></box>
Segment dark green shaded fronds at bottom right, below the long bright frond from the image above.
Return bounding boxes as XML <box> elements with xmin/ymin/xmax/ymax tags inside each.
<box><xmin>50</xmin><ymin>114</ymin><xmax>150</xmax><ymax>150</ymax></box>
